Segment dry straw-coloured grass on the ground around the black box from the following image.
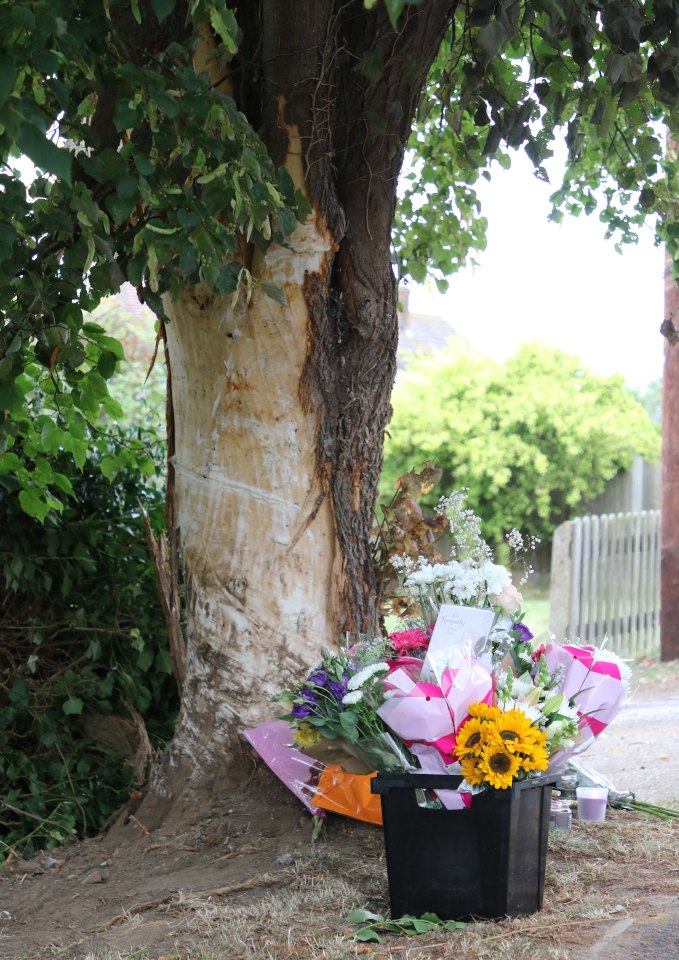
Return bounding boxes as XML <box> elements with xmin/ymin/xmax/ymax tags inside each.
<box><xmin>57</xmin><ymin>812</ymin><xmax>679</xmax><ymax>960</ymax></box>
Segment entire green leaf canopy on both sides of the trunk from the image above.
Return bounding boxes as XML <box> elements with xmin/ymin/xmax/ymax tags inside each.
<box><xmin>0</xmin><ymin>0</ymin><xmax>679</xmax><ymax>520</ymax></box>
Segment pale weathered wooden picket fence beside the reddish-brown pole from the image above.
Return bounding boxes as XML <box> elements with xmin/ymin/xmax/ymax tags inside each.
<box><xmin>549</xmin><ymin>510</ymin><xmax>660</xmax><ymax>657</ymax></box>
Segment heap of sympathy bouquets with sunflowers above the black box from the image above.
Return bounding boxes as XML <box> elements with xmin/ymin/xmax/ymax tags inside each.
<box><xmin>246</xmin><ymin>491</ymin><xmax>629</xmax><ymax>819</ymax></box>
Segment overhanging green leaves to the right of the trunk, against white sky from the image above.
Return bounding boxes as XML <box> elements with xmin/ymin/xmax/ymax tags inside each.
<box><xmin>394</xmin><ymin>0</ymin><xmax>679</xmax><ymax>290</ymax></box>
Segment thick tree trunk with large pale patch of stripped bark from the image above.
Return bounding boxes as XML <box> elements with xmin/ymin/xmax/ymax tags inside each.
<box><xmin>153</xmin><ymin>0</ymin><xmax>454</xmax><ymax>796</ymax></box>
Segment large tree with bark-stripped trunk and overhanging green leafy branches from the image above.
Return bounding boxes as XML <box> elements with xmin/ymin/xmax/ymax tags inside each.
<box><xmin>0</xmin><ymin>0</ymin><xmax>679</xmax><ymax>808</ymax></box>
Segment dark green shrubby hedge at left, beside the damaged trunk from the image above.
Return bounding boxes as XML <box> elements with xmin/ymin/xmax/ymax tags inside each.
<box><xmin>0</xmin><ymin>406</ymin><xmax>177</xmax><ymax>860</ymax></box>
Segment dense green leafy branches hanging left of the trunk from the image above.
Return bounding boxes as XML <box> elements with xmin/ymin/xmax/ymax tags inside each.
<box><xmin>0</xmin><ymin>0</ymin><xmax>308</xmax><ymax>520</ymax></box>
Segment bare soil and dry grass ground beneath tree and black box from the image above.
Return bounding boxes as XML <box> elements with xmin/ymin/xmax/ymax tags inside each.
<box><xmin>0</xmin><ymin>767</ymin><xmax>679</xmax><ymax>960</ymax></box>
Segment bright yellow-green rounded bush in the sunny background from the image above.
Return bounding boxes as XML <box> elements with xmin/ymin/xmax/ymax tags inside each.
<box><xmin>382</xmin><ymin>346</ymin><xmax>660</xmax><ymax>545</ymax></box>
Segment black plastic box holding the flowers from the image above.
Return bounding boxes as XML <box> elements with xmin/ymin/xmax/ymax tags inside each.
<box><xmin>371</xmin><ymin>773</ymin><xmax>556</xmax><ymax>920</ymax></box>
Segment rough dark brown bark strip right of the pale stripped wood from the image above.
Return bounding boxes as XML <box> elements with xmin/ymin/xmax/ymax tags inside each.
<box><xmin>238</xmin><ymin>0</ymin><xmax>455</xmax><ymax>631</ymax></box>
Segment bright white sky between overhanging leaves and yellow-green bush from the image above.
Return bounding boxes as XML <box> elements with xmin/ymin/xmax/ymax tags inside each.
<box><xmin>409</xmin><ymin>153</ymin><xmax>664</xmax><ymax>389</ymax></box>
